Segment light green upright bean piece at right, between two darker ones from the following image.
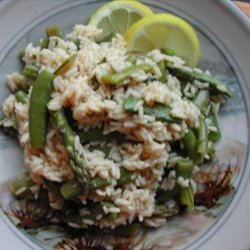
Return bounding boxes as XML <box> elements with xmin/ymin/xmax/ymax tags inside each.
<box><xmin>197</xmin><ymin>118</ymin><xmax>208</xmax><ymax>155</ymax></box>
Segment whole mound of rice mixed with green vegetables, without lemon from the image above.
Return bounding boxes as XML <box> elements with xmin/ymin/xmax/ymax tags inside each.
<box><xmin>1</xmin><ymin>24</ymin><xmax>229</xmax><ymax>232</ymax></box>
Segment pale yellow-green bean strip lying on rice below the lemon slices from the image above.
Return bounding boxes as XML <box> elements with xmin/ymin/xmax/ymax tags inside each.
<box><xmin>102</xmin><ymin>63</ymin><xmax>155</xmax><ymax>84</ymax></box>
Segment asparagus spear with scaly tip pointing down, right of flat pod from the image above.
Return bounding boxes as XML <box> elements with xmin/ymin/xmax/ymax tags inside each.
<box><xmin>51</xmin><ymin>110</ymin><xmax>89</xmax><ymax>186</ymax></box>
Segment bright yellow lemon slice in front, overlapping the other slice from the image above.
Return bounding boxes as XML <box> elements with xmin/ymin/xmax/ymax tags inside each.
<box><xmin>125</xmin><ymin>14</ymin><xmax>200</xmax><ymax>67</ymax></box>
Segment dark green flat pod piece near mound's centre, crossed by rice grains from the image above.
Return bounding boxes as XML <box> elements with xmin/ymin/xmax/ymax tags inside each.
<box><xmin>123</xmin><ymin>96</ymin><xmax>181</xmax><ymax>124</ymax></box>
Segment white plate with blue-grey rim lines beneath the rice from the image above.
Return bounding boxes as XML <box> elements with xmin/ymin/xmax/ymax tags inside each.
<box><xmin>0</xmin><ymin>0</ymin><xmax>250</xmax><ymax>250</ymax></box>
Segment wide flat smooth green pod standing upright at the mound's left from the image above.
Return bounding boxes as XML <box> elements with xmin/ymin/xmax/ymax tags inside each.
<box><xmin>29</xmin><ymin>70</ymin><xmax>54</xmax><ymax>148</ymax></box>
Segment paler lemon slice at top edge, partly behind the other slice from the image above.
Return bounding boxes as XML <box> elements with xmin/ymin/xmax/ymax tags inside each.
<box><xmin>89</xmin><ymin>0</ymin><xmax>153</xmax><ymax>35</ymax></box>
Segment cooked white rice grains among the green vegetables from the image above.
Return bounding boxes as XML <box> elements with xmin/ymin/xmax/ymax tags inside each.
<box><xmin>0</xmin><ymin>25</ymin><xmax>223</xmax><ymax>228</ymax></box>
